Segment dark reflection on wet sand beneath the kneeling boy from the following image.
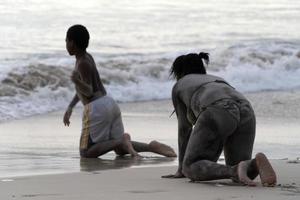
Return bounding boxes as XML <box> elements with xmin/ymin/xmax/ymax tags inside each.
<box><xmin>80</xmin><ymin>156</ymin><xmax>176</xmax><ymax>172</ymax></box>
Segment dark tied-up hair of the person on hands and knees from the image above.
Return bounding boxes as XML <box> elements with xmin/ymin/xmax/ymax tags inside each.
<box><xmin>170</xmin><ymin>52</ymin><xmax>209</xmax><ymax>80</ymax></box>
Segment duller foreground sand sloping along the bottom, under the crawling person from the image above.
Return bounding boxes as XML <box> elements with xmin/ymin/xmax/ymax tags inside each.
<box><xmin>0</xmin><ymin>160</ymin><xmax>300</xmax><ymax>200</ymax></box>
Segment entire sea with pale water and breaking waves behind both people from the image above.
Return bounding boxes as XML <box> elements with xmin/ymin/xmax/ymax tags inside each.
<box><xmin>0</xmin><ymin>0</ymin><xmax>300</xmax><ymax>121</ymax></box>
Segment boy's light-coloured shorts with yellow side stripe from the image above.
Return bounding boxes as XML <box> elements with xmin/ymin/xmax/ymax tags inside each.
<box><xmin>80</xmin><ymin>96</ymin><xmax>124</xmax><ymax>150</ymax></box>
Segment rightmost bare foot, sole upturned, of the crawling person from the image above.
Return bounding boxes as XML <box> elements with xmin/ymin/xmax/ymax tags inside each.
<box><xmin>255</xmin><ymin>153</ymin><xmax>276</xmax><ymax>187</ymax></box>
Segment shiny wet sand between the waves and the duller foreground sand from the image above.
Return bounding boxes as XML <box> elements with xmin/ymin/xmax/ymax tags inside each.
<box><xmin>0</xmin><ymin>91</ymin><xmax>300</xmax><ymax>177</ymax></box>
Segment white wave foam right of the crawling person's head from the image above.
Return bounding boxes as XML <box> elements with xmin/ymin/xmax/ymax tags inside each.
<box><xmin>213</xmin><ymin>41</ymin><xmax>300</xmax><ymax>92</ymax></box>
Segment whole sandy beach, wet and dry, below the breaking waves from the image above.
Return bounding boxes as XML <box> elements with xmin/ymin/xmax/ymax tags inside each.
<box><xmin>0</xmin><ymin>91</ymin><xmax>300</xmax><ymax>200</ymax></box>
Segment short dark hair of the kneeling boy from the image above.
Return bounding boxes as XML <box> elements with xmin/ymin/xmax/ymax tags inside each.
<box><xmin>67</xmin><ymin>24</ymin><xmax>90</xmax><ymax>50</ymax></box>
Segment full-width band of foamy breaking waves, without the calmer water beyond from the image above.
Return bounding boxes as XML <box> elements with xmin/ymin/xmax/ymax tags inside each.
<box><xmin>0</xmin><ymin>41</ymin><xmax>300</xmax><ymax>121</ymax></box>
